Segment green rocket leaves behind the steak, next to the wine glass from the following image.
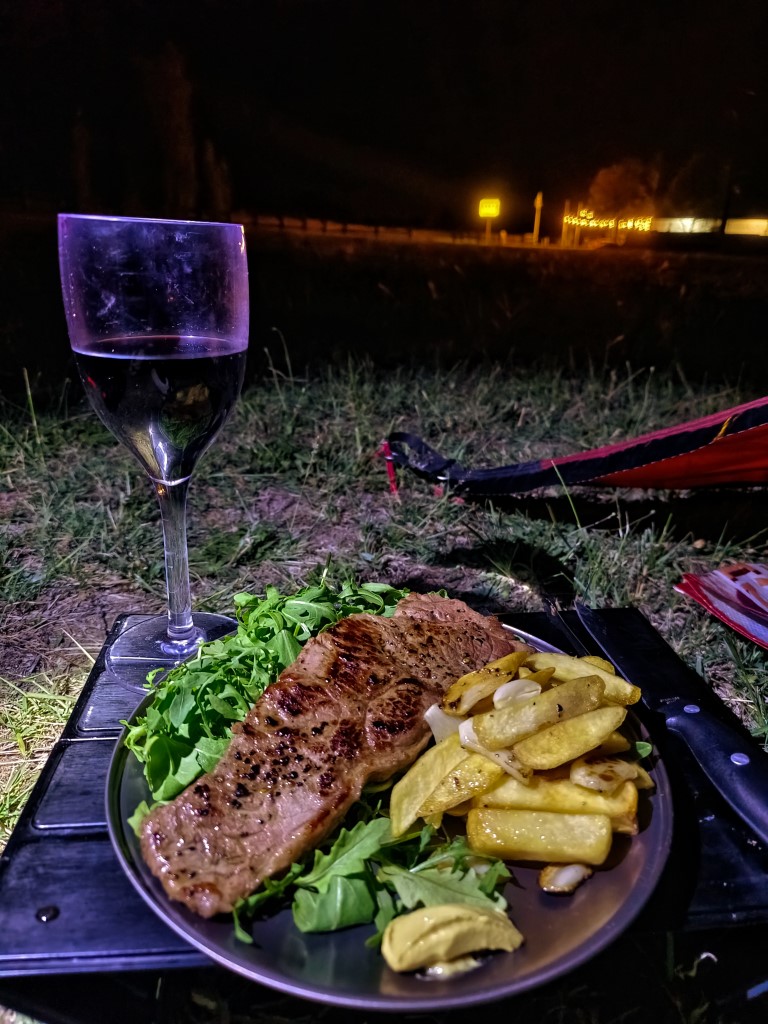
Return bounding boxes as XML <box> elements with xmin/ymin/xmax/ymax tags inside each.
<box><xmin>126</xmin><ymin>582</ymin><xmax>407</xmax><ymax>802</ymax></box>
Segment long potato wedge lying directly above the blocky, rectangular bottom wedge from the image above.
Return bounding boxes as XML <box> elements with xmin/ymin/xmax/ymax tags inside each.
<box><xmin>472</xmin><ymin>775</ymin><xmax>638</xmax><ymax>836</ymax></box>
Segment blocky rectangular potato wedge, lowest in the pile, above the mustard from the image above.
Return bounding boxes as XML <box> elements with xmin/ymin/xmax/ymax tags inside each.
<box><xmin>467</xmin><ymin>807</ymin><xmax>612</xmax><ymax>864</ymax></box>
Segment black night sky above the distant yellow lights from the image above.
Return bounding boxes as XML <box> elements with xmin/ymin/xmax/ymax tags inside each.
<box><xmin>0</xmin><ymin>0</ymin><xmax>768</xmax><ymax>229</ymax></box>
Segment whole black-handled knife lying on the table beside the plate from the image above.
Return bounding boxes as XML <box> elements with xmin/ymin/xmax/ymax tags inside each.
<box><xmin>575</xmin><ymin>602</ymin><xmax>768</xmax><ymax>846</ymax></box>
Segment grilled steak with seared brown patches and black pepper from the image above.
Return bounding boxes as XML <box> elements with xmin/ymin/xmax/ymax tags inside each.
<box><xmin>141</xmin><ymin>594</ymin><xmax>521</xmax><ymax>918</ymax></box>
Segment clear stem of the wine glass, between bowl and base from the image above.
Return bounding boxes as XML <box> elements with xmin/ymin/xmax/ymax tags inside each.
<box><xmin>154</xmin><ymin>477</ymin><xmax>195</xmax><ymax>643</ymax></box>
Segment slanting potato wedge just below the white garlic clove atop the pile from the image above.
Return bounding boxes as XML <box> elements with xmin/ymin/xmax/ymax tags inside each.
<box><xmin>473</xmin><ymin>676</ymin><xmax>605</xmax><ymax>751</ymax></box>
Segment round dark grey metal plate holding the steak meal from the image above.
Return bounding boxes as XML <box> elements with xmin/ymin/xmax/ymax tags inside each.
<box><xmin>106</xmin><ymin>645</ymin><xmax>672</xmax><ymax>1012</ymax></box>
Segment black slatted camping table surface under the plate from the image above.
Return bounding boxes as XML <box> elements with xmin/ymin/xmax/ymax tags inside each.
<box><xmin>0</xmin><ymin>608</ymin><xmax>768</xmax><ymax>1024</ymax></box>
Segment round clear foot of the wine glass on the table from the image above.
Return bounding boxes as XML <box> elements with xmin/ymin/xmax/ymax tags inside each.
<box><xmin>105</xmin><ymin>611</ymin><xmax>238</xmax><ymax>690</ymax></box>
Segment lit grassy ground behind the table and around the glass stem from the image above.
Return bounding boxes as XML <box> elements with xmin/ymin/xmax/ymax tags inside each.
<box><xmin>0</xmin><ymin>361</ymin><xmax>768</xmax><ymax>1020</ymax></box>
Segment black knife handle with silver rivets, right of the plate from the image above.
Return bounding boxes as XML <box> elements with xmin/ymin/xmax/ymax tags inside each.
<box><xmin>666</xmin><ymin>703</ymin><xmax>768</xmax><ymax>849</ymax></box>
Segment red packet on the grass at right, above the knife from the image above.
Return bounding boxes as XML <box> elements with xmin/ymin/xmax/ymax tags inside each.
<box><xmin>675</xmin><ymin>562</ymin><xmax>768</xmax><ymax>648</ymax></box>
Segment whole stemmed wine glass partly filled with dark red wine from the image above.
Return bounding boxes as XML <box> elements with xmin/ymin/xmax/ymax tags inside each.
<box><xmin>58</xmin><ymin>213</ymin><xmax>249</xmax><ymax>683</ymax></box>
